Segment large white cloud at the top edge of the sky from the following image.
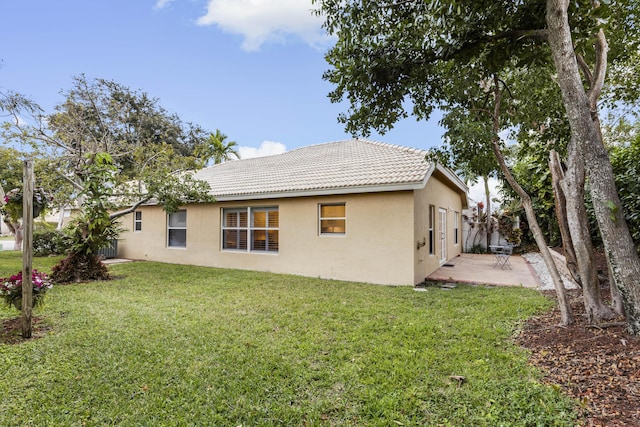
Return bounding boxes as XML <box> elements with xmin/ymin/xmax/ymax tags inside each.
<box><xmin>195</xmin><ymin>0</ymin><xmax>329</xmax><ymax>51</ymax></box>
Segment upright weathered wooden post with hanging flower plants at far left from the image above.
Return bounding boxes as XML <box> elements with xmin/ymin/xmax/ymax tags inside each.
<box><xmin>22</xmin><ymin>160</ymin><xmax>34</xmax><ymax>338</ymax></box>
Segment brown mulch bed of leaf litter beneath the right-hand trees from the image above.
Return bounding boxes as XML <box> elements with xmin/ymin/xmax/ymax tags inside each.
<box><xmin>517</xmin><ymin>290</ymin><xmax>640</xmax><ymax>427</ymax></box>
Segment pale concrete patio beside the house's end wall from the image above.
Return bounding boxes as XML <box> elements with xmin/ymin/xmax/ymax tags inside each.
<box><xmin>427</xmin><ymin>254</ymin><xmax>540</xmax><ymax>289</ymax></box>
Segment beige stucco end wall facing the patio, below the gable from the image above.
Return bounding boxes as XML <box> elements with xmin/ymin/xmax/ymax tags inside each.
<box><xmin>414</xmin><ymin>172</ymin><xmax>466</xmax><ymax>283</ymax></box>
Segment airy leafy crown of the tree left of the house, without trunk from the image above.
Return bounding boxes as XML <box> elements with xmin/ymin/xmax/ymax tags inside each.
<box><xmin>4</xmin><ymin>75</ymin><xmax>211</xmax><ymax>216</ymax></box>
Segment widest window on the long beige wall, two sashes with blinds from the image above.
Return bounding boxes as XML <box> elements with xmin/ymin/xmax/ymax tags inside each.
<box><xmin>222</xmin><ymin>207</ymin><xmax>279</xmax><ymax>252</ymax></box>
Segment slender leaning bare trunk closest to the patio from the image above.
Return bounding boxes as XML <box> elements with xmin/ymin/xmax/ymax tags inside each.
<box><xmin>491</xmin><ymin>75</ymin><xmax>574</xmax><ymax>326</ymax></box>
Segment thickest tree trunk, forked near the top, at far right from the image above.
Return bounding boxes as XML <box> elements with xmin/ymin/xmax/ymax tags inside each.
<box><xmin>546</xmin><ymin>0</ymin><xmax>640</xmax><ymax>335</ymax></box>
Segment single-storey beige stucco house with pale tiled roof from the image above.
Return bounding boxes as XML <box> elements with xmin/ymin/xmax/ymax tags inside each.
<box><xmin>118</xmin><ymin>139</ymin><xmax>467</xmax><ymax>285</ymax></box>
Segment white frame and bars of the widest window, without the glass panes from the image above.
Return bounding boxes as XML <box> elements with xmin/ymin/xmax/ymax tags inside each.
<box><xmin>220</xmin><ymin>206</ymin><xmax>280</xmax><ymax>254</ymax></box>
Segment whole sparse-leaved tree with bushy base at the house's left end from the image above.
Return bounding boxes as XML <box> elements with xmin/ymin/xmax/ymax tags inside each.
<box><xmin>5</xmin><ymin>76</ymin><xmax>218</xmax><ymax>280</ymax></box>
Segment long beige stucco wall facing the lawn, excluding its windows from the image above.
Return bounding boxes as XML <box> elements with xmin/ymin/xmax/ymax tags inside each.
<box><xmin>118</xmin><ymin>191</ymin><xmax>418</xmax><ymax>285</ymax></box>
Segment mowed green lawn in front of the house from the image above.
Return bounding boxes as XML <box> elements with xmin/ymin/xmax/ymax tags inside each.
<box><xmin>0</xmin><ymin>252</ymin><xmax>576</xmax><ymax>426</ymax></box>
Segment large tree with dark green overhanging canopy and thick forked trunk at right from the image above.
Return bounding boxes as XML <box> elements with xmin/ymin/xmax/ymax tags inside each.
<box><xmin>316</xmin><ymin>0</ymin><xmax>640</xmax><ymax>333</ymax></box>
